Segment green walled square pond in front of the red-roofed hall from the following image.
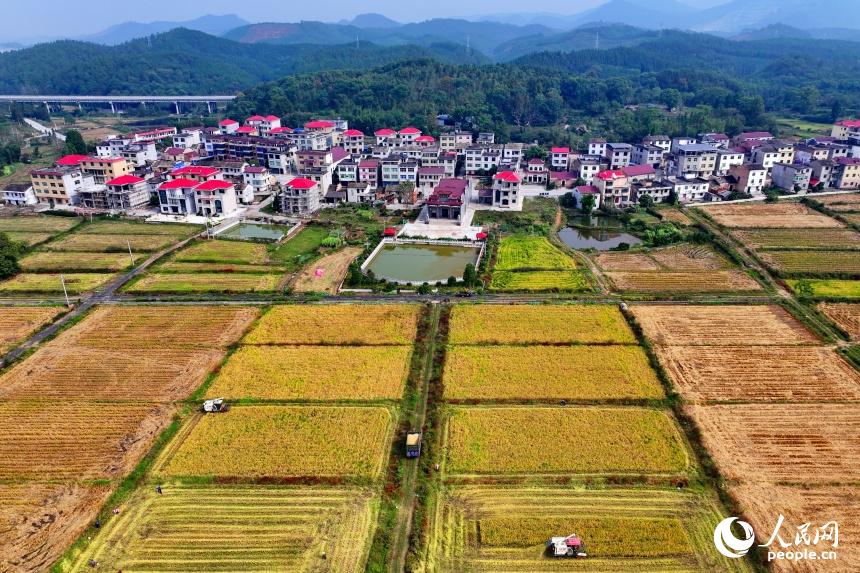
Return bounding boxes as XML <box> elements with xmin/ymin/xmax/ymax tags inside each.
<box><xmin>365</xmin><ymin>245</ymin><xmax>480</xmax><ymax>285</ymax></box>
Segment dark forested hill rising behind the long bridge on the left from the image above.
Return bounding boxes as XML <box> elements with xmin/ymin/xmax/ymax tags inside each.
<box><xmin>0</xmin><ymin>28</ymin><xmax>488</xmax><ymax>95</ymax></box>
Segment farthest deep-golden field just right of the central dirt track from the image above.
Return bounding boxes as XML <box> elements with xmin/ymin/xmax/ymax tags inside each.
<box><xmin>448</xmin><ymin>304</ymin><xmax>636</xmax><ymax>344</ymax></box>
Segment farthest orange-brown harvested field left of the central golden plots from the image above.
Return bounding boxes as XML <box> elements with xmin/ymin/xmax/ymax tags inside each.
<box><xmin>57</xmin><ymin>305</ymin><xmax>259</xmax><ymax>350</ymax></box>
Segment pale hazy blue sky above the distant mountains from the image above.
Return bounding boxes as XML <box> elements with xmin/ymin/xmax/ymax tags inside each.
<box><xmin>0</xmin><ymin>0</ymin><xmax>727</xmax><ymax>41</ymax></box>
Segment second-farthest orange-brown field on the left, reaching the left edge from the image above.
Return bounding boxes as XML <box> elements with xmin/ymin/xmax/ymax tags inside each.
<box><xmin>0</xmin><ymin>344</ymin><xmax>226</xmax><ymax>402</ymax></box>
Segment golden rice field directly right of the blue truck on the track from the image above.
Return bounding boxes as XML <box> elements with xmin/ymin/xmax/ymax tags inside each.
<box><xmin>446</xmin><ymin>408</ymin><xmax>688</xmax><ymax>474</ymax></box>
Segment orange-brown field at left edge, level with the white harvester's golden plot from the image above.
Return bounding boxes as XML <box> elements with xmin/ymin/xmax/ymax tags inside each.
<box><xmin>0</xmin><ymin>401</ymin><xmax>175</xmax><ymax>480</ymax></box>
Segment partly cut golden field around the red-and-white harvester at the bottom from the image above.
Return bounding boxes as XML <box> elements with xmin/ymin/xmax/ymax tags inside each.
<box><xmin>421</xmin><ymin>485</ymin><xmax>752</xmax><ymax>573</ymax></box>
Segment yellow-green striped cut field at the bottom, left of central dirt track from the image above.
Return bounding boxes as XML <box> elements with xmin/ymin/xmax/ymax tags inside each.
<box><xmin>63</xmin><ymin>483</ymin><xmax>377</xmax><ymax>573</ymax></box>
